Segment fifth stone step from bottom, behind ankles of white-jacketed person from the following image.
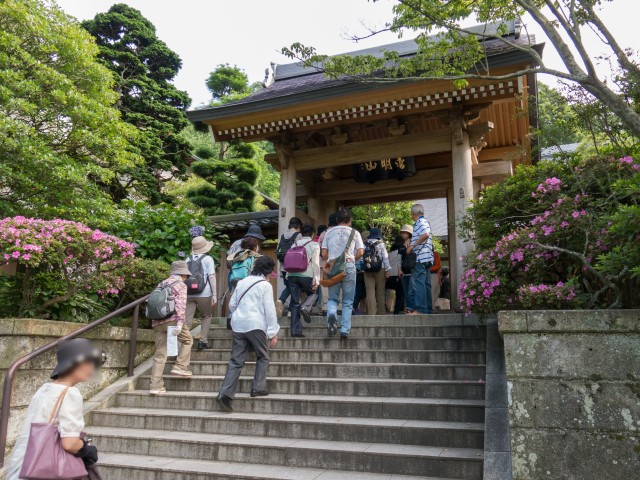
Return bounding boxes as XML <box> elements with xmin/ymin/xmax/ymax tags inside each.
<box><xmin>137</xmin><ymin>375</ymin><xmax>484</xmax><ymax>400</ymax></box>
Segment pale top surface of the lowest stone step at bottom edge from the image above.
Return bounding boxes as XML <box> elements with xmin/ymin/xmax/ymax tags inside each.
<box><xmin>100</xmin><ymin>453</ymin><xmax>455</xmax><ymax>480</ymax></box>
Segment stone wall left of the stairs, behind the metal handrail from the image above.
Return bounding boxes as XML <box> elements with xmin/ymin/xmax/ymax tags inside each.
<box><xmin>0</xmin><ymin>318</ymin><xmax>153</xmax><ymax>446</ymax></box>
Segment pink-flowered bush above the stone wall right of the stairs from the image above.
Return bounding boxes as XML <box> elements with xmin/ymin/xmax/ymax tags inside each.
<box><xmin>459</xmin><ymin>157</ymin><xmax>640</xmax><ymax>316</ymax></box>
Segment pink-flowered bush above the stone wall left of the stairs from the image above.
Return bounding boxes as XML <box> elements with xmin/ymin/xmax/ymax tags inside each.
<box><xmin>0</xmin><ymin>216</ymin><xmax>134</xmax><ymax>312</ymax></box>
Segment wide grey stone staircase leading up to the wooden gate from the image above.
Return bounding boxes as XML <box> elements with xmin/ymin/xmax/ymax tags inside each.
<box><xmin>87</xmin><ymin>315</ymin><xmax>485</xmax><ymax>480</ymax></box>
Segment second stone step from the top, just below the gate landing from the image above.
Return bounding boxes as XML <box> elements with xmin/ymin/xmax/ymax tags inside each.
<box><xmin>209</xmin><ymin>321</ymin><xmax>485</xmax><ymax>339</ymax></box>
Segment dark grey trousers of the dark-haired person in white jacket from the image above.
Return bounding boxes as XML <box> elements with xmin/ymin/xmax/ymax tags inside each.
<box><xmin>220</xmin><ymin>330</ymin><xmax>269</xmax><ymax>398</ymax></box>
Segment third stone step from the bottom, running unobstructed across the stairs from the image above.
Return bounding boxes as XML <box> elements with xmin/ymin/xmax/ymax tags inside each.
<box><xmin>91</xmin><ymin>407</ymin><xmax>484</xmax><ymax>449</ymax></box>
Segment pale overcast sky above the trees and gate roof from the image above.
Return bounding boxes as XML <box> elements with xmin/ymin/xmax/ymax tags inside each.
<box><xmin>57</xmin><ymin>0</ymin><xmax>640</xmax><ymax>106</ymax></box>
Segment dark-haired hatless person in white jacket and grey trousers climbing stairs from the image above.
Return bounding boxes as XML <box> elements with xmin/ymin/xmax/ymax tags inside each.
<box><xmin>216</xmin><ymin>257</ymin><xmax>280</xmax><ymax>412</ymax></box>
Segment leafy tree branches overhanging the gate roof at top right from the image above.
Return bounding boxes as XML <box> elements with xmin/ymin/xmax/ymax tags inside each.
<box><xmin>283</xmin><ymin>0</ymin><xmax>640</xmax><ymax>135</ymax></box>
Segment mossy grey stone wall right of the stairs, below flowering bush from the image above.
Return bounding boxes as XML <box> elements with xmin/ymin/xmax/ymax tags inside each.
<box><xmin>498</xmin><ymin>310</ymin><xmax>640</xmax><ymax>480</ymax></box>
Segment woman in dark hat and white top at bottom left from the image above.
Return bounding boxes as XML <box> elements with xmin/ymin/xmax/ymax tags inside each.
<box><xmin>7</xmin><ymin>338</ymin><xmax>105</xmax><ymax>480</ymax></box>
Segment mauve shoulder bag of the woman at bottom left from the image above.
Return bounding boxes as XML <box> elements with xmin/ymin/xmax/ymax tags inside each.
<box><xmin>19</xmin><ymin>387</ymin><xmax>88</xmax><ymax>480</ymax></box>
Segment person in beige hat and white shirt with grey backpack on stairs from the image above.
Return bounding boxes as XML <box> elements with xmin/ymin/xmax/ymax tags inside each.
<box><xmin>187</xmin><ymin>236</ymin><xmax>218</xmax><ymax>350</ymax></box>
